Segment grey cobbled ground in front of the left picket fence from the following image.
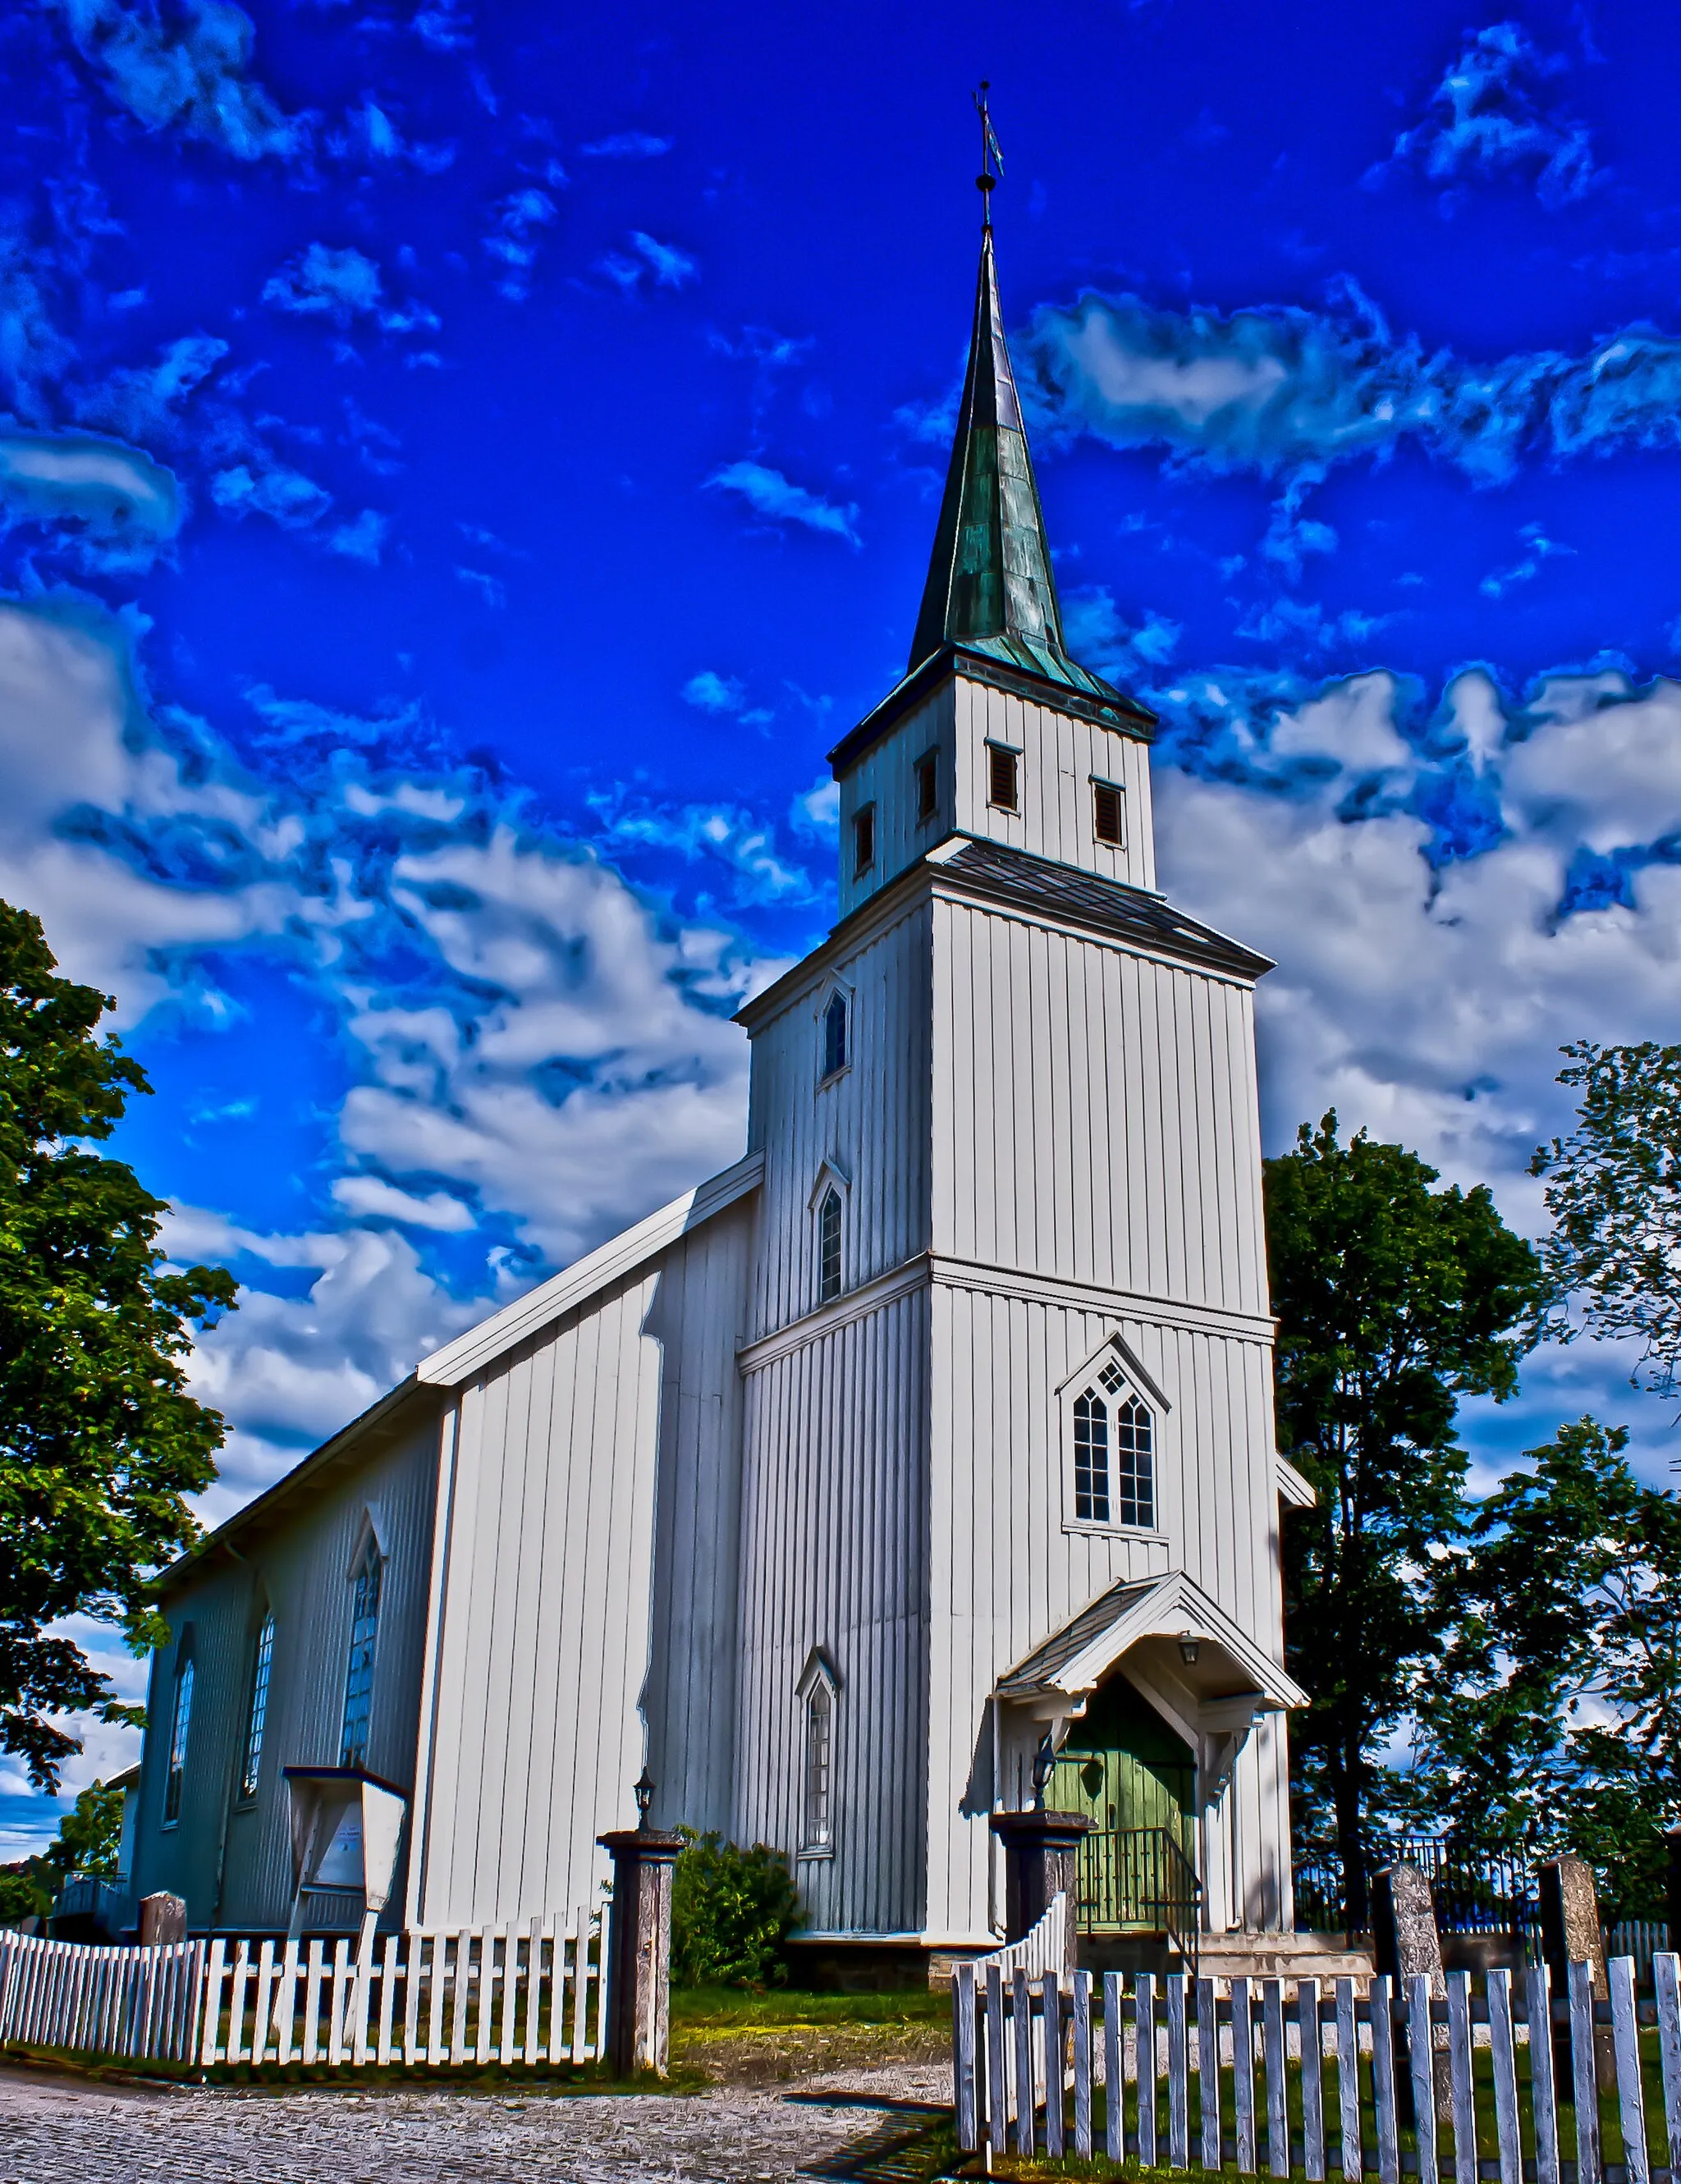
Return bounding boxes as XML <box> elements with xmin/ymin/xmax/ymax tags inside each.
<box><xmin>0</xmin><ymin>2068</ymin><xmax>950</xmax><ymax>2184</ymax></box>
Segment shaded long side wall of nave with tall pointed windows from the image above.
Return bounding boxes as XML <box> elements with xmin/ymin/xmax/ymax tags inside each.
<box><xmin>135</xmin><ymin>1404</ymin><xmax>439</xmax><ymax>1929</ymax></box>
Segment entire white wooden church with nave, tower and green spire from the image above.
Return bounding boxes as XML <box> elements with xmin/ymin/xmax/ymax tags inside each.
<box><xmin>133</xmin><ymin>234</ymin><xmax>1308</xmax><ymax>1972</ymax></box>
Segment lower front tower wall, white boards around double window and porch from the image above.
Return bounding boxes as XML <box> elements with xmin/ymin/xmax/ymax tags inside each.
<box><xmin>928</xmin><ymin>1282</ymin><xmax>1288</xmax><ymax>1937</ymax></box>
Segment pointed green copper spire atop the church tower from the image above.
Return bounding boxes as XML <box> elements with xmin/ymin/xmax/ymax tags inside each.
<box><xmin>910</xmin><ymin>225</ymin><xmax>1113</xmax><ymax>697</ymax></box>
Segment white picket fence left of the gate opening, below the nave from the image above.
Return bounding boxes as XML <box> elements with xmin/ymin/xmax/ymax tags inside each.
<box><xmin>0</xmin><ymin>1911</ymin><xmax>607</xmax><ymax>2071</ymax></box>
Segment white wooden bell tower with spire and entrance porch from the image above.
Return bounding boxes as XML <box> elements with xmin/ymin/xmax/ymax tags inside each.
<box><xmin>734</xmin><ymin>196</ymin><xmax>1299</xmax><ymax>1953</ymax></box>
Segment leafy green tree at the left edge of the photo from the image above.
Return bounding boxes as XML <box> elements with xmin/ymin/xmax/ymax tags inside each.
<box><xmin>0</xmin><ymin>904</ymin><xmax>234</xmax><ymax>1788</ymax></box>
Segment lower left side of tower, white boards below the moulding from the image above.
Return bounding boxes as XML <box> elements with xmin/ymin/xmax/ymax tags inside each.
<box><xmin>734</xmin><ymin>1291</ymin><xmax>928</xmax><ymax>1933</ymax></box>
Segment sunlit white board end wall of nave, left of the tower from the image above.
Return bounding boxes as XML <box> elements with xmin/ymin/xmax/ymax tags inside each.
<box><xmin>419</xmin><ymin>1203</ymin><xmax>753</xmax><ymax>1926</ymax></box>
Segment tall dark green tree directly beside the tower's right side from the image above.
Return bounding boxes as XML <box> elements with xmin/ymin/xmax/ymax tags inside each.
<box><xmin>1266</xmin><ymin>1114</ymin><xmax>1541</xmax><ymax>1924</ymax></box>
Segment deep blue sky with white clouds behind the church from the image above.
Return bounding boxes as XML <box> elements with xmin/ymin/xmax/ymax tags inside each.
<box><xmin>0</xmin><ymin>0</ymin><xmax>1681</xmax><ymax>1843</ymax></box>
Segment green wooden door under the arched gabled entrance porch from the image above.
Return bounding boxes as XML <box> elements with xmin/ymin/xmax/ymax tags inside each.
<box><xmin>1046</xmin><ymin>1675</ymin><xmax>1197</xmax><ymax>1933</ymax></box>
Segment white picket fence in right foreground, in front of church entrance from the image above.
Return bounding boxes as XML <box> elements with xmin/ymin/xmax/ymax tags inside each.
<box><xmin>952</xmin><ymin>1950</ymin><xmax>1681</xmax><ymax>2184</ymax></box>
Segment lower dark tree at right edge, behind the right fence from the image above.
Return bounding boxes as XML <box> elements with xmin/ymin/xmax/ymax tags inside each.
<box><xmin>1413</xmin><ymin>1417</ymin><xmax>1681</xmax><ymax>1916</ymax></box>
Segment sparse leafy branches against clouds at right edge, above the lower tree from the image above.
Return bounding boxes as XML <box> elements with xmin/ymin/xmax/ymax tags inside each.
<box><xmin>1530</xmin><ymin>1040</ymin><xmax>1681</xmax><ymax>1395</ymax></box>
